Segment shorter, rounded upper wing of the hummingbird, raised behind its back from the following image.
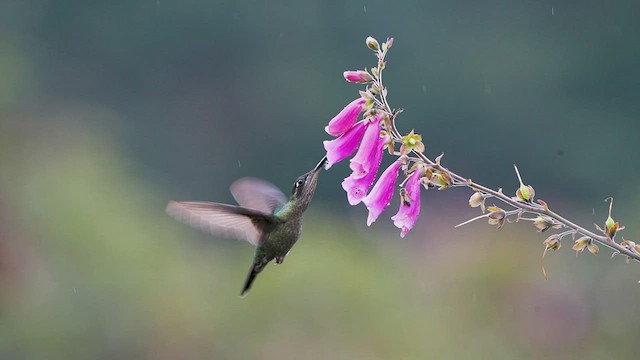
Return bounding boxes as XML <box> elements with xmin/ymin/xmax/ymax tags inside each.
<box><xmin>231</xmin><ymin>177</ymin><xmax>287</xmax><ymax>214</ymax></box>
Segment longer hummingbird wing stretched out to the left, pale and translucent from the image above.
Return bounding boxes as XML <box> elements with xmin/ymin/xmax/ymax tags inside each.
<box><xmin>167</xmin><ymin>201</ymin><xmax>280</xmax><ymax>245</ymax></box>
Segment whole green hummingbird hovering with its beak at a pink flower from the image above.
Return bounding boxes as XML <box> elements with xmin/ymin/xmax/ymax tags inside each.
<box><xmin>166</xmin><ymin>156</ymin><xmax>327</xmax><ymax>296</ymax></box>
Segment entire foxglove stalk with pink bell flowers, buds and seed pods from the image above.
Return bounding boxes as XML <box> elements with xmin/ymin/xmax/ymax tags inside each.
<box><xmin>324</xmin><ymin>37</ymin><xmax>640</xmax><ymax>268</ymax></box>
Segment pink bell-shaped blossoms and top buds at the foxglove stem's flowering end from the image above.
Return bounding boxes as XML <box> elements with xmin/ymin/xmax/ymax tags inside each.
<box><xmin>324</xmin><ymin>38</ymin><xmax>426</xmax><ymax>237</ymax></box>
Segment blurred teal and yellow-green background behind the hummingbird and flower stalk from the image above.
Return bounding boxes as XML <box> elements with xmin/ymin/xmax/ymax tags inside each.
<box><xmin>0</xmin><ymin>0</ymin><xmax>640</xmax><ymax>359</ymax></box>
